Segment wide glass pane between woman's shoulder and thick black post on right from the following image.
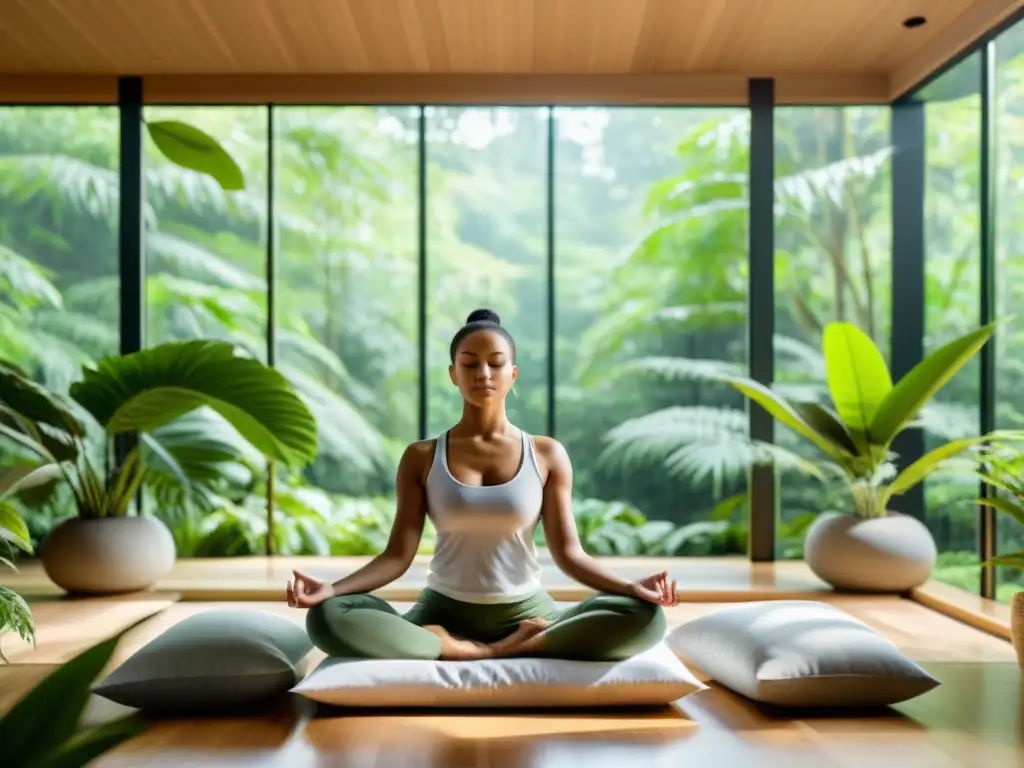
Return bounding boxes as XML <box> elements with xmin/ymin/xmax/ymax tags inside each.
<box><xmin>555</xmin><ymin>108</ymin><xmax>750</xmax><ymax>555</ymax></box>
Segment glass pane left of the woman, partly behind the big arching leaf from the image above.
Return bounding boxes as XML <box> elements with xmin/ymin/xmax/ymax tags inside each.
<box><xmin>274</xmin><ymin>106</ymin><xmax>421</xmax><ymax>555</ymax></box>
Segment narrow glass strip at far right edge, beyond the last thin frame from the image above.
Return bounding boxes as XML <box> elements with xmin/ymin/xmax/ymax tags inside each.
<box><xmin>995</xmin><ymin>24</ymin><xmax>1024</xmax><ymax>602</ymax></box>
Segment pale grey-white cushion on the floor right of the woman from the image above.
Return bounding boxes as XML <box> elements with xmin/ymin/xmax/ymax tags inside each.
<box><xmin>666</xmin><ymin>600</ymin><xmax>939</xmax><ymax>707</ymax></box>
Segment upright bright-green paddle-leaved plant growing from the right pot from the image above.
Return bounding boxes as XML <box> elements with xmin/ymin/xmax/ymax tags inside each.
<box><xmin>724</xmin><ymin>323</ymin><xmax>1009</xmax><ymax>517</ymax></box>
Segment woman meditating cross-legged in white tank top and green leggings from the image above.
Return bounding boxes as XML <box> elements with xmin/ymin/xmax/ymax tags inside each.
<box><xmin>287</xmin><ymin>309</ymin><xmax>678</xmax><ymax>662</ymax></box>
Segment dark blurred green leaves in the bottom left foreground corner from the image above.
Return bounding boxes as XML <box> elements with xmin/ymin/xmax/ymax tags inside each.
<box><xmin>0</xmin><ymin>628</ymin><xmax>146</xmax><ymax>768</ymax></box>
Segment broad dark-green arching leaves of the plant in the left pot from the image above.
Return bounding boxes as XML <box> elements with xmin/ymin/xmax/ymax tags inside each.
<box><xmin>0</xmin><ymin>340</ymin><xmax>317</xmax><ymax>517</ymax></box>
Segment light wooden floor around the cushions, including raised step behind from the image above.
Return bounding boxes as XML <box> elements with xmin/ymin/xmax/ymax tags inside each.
<box><xmin>0</xmin><ymin>558</ymin><xmax>1024</xmax><ymax>768</ymax></box>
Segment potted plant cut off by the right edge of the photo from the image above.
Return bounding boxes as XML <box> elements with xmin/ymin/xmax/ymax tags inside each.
<box><xmin>978</xmin><ymin>445</ymin><xmax>1024</xmax><ymax>669</ymax></box>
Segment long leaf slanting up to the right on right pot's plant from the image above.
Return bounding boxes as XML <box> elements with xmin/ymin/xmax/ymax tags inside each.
<box><xmin>867</xmin><ymin>323</ymin><xmax>998</xmax><ymax>445</ymax></box>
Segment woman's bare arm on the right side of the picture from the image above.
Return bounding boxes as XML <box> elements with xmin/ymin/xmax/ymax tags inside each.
<box><xmin>535</xmin><ymin>437</ymin><xmax>636</xmax><ymax>595</ymax></box>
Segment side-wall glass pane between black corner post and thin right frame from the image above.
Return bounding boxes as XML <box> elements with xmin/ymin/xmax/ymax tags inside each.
<box><xmin>922</xmin><ymin>55</ymin><xmax>981</xmax><ymax>594</ymax></box>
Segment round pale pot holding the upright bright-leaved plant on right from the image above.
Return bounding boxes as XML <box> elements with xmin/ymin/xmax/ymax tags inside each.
<box><xmin>804</xmin><ymin>512</ymin><xmax>938</xmax><ymax>593</ymax></box>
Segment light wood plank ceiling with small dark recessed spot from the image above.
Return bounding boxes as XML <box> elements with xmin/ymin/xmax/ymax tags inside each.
<box><xmin>0</xmin><ymin>0</ymin><xmax>1024</xmax><ymax>103</ymax></box>
